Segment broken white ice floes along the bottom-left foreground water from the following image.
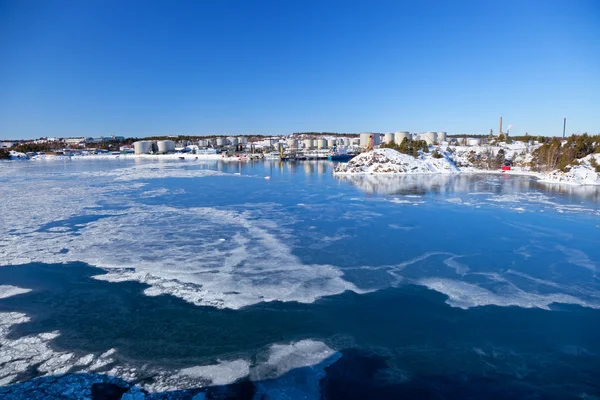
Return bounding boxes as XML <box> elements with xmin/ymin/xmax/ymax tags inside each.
<box><xmin>0</xmin><ymin>312</ymin><xmax>340</xmax><ymax>399</ymax></box>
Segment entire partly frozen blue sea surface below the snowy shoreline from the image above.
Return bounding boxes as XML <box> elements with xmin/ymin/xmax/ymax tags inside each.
<box><xmin>0</xmin><ymin>159</ymin><xmax>600</xmax><ymax>400</ymax></box>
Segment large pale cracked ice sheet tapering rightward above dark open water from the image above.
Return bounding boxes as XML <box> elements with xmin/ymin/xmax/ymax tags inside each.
<box><xmin>0</xmin><ymin>206</ymin><xmax>359</xmax><ymax>309</ymax></box>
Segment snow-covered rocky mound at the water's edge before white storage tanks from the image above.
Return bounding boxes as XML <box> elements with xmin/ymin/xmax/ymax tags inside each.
<box><xmin>335</xmin><ymin>149</ymin><xmax>459</xmax><ymax>174</ymax></box>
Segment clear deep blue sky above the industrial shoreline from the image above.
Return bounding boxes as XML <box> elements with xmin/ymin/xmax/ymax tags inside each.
<box><xmin>0</xmin><ymin>0</ymin><xmax>600</xmax><ymax>139</ymax></box>
